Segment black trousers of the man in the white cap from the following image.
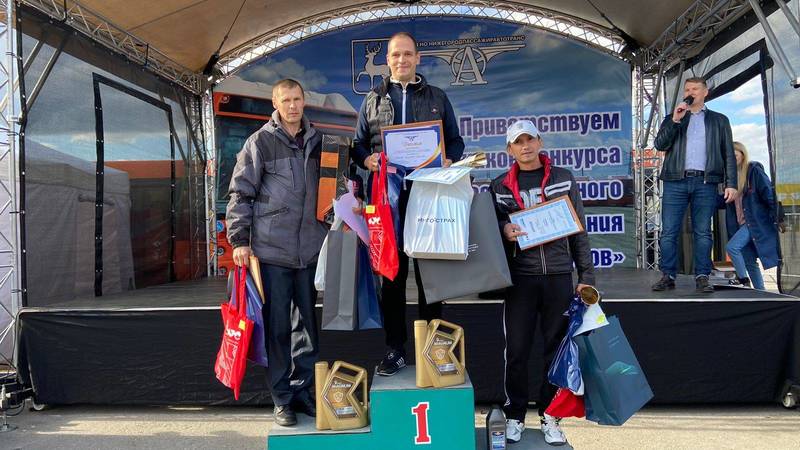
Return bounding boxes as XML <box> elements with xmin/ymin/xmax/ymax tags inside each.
<box><xmin>503</xmin><ymin>272</ymin><xmax>575</xmax><ymax>421</ymax></box>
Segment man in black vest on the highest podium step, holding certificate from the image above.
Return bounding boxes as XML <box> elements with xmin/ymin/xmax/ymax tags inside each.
<box><xmin>350</xmin><ymin>32</ymin><xmax>464</xmax><ymax>376</ymax></box>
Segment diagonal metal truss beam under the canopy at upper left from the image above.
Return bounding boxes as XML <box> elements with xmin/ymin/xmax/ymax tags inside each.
<box><xmin>20</xmin><ymin>0</ymin><xmax>202</xmax><ymax>95</ymax></box>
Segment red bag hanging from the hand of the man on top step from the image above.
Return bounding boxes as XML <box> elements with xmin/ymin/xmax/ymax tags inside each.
<box><xmin>364</xmin><ymin>152</ymin><xmax>400</xmax><ymax>280</ymax></box>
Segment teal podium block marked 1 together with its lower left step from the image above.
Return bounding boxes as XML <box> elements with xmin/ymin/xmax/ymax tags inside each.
<box><xmin>267</xmin><ymin>366</ymin><xmax>475</xmax><ymax>450</ymax></box>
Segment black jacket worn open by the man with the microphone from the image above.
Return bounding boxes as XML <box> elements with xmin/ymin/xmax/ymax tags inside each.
<box><xmin>655</xmin><ymin>109</ymin><xmax>736</xmax><ymax>189</ymax></box>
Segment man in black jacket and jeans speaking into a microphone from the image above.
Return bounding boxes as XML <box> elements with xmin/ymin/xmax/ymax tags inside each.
<box><xmin>652</xmin><ymin>78</ymin><xmax>736</xmax><ymax>293</ymax></box>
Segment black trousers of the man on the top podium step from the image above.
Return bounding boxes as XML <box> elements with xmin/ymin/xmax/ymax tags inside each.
<box><xmin>381</xmin><ymin>183</ymin><xmax>442</xmax><ymax>352</ymax></box>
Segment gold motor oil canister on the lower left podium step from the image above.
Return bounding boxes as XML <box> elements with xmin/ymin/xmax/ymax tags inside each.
<box><xmin>314</xmin><ymin>361</ymin><xmax>369</xmax><ymax>430</ymax></box>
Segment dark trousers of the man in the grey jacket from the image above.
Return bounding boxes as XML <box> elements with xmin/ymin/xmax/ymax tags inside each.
<box><xmin>261</xmin><ymin>263</ymin><xmax>319</xmax><ymax>405</ymax></box>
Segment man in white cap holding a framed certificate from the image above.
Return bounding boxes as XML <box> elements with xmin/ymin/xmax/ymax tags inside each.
<box><xmin>490</xmin><ymin>120</ymin><xmax>594</xmax><ymax>445</ymax></box>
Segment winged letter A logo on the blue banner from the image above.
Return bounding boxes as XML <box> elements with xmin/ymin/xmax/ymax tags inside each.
<box><xmin>419</xmin><ymin>44</ymin><xmax>525</xmax><ymax>86</ymax></box>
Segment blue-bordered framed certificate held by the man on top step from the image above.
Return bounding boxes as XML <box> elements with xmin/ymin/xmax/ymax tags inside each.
<box><xmin>381</xmin><ymin>120</ymin><xmax>445</xmax><ymax>169</ymax></box>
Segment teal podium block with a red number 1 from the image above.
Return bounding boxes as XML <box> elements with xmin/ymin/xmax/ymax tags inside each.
<box><xmin>370</xmin><ymin>366</ymin><xmax>475</xmax><ymax>450</ymax></box>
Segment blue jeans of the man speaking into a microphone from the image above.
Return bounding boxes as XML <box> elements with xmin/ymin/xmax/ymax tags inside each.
<box><xmin>660</xmin><ymin>177</ymin><xmax>717</xmax><ymax>278</ymax></box>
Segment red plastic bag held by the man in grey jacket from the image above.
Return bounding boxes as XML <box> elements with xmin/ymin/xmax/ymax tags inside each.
<box><xmin>214</xmin><ymin>269</ymin><xmax>253</xmax><ymax>400</ymax></box>
